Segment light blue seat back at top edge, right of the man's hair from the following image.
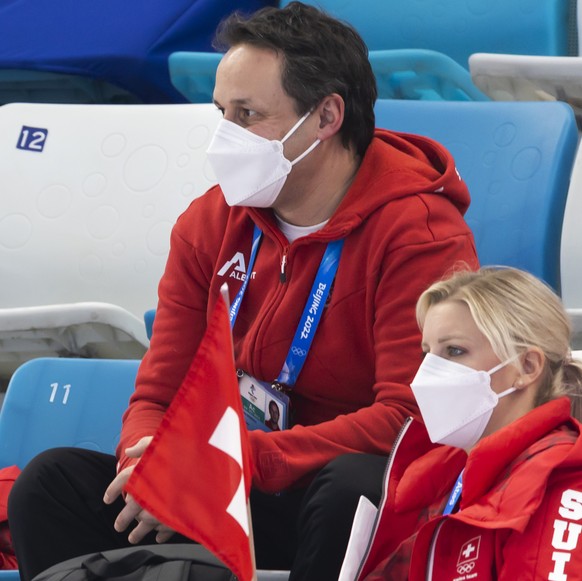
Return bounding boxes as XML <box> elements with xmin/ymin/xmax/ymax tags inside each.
<box><xmin>281</xmin><ymin>0</ymin><xmax>571</xmax><ymax>68</ymax></box>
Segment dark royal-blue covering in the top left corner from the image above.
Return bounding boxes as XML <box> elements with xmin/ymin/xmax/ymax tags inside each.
<box><xmin>0</xmin><ymin>0</ymin><xmax>275</xmax><ymax>103</ymax></box>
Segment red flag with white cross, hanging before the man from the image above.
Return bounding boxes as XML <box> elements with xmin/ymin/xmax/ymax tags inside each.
<box><xmin>126</xmin><ymin>298</ymin><xmax>254</xmax><ymax>581</ymax></box>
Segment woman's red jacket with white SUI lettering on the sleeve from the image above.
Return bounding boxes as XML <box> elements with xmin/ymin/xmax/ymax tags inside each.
<box><xmin>359</xmin><ymin>397</ymin><xmax>582</xmax><ymax>581</ymax></box>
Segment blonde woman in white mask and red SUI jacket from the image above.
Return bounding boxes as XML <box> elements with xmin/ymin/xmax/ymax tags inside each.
<box><xmin>358</xmin><ymin>268</ymin><xmax>582</xmax><ymax>581</ymax></box>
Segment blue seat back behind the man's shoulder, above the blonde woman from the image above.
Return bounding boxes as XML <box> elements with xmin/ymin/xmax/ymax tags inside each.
<box><xmin>376</xmin><ymin>100</ymin><xmax>578</xmax><ymax>292</ymax></box>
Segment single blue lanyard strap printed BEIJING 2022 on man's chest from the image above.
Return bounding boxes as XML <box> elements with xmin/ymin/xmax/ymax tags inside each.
<box><xmin>277</xmin><ymin>240</ymin><xmax>344</xmax><ymax>387</ymax></box>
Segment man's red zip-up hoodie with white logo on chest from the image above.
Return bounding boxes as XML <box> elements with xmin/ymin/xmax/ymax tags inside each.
<box><xmin>118</xmin><ymin>130</ymin><xmax>477</xmax><ymax>492</ymax></box>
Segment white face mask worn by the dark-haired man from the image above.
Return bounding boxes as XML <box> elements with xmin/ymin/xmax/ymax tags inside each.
<box><xmin>206</xmin><ymin>112</ymin><xmax>320</xmax><ymax>208</ymax></box>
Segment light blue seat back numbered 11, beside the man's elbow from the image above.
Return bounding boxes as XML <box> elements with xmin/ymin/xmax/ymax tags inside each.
<box><xmin>0</xmin><ymin>358</ymin><xmax>139</xmax><ymax>581</ymax></box>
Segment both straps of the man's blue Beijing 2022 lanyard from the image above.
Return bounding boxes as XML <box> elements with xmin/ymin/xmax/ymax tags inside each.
<box><xmin>229</xmin><ymin>224</ymin><xmax>344</xmax><ymax>386</ymax></box>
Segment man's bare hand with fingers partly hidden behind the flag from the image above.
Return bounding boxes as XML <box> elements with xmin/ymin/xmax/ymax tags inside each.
<box><xmin>103</xmin><ymin>436</ymin><xmax>174</xmax><ymax>544</ymax></box>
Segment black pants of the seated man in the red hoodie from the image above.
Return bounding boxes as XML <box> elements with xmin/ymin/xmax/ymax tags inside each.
<box><xmin>8</xmin><ymin>448</ymin><xmax>386</xmax><ymax>581</ymax></box>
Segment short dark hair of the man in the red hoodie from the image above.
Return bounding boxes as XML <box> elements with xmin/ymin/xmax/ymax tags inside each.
<box><xmin>214</xmin><ymin>2</ymin><xmax>377</xmax><ymax>156</ymax></box>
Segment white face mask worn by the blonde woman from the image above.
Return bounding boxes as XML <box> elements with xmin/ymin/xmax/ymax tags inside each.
<box><xmin>410</xmin><ymin>353</ymin><xmax>515</xmax><ymax>450</ymax></box>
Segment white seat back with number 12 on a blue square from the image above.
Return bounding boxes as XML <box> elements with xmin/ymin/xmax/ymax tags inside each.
<box><xmin>0</xmin><ymin>104</ymin><xmax>220</xmax><ymax>318</ymax></box>
